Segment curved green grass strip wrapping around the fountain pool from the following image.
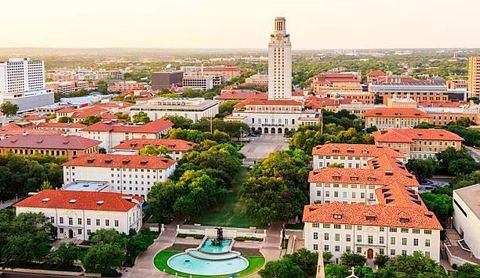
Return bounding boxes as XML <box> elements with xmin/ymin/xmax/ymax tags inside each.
<box><xmin>153</xmin><ymin>250</ymin><xmax>265</xmax><ymax>278</ymax></box>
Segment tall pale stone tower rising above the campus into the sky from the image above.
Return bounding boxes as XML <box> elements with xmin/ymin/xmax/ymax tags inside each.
<box><xmin>268</xmin><ymin>17</ymin><xmax>292</xmax><ymax>99</ymax></box>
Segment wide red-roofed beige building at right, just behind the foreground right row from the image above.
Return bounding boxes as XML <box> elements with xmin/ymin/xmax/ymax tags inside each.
<box><xmin>373</xmin><ymin>129</ymin><xmax>463</xmax><ymax>159</ymax></box>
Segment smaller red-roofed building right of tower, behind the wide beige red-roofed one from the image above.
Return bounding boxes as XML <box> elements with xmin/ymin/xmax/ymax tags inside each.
<box><xmin>363</xmin><ymin>108</ymin><xmax>431</xmax><ymax>130</ymax></box>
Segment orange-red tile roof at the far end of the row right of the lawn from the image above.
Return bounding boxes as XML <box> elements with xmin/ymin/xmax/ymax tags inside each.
<box><xmin>312</xmin><ymin>143</ymin><xmax>402</xmax><ymax>158</ymax></box>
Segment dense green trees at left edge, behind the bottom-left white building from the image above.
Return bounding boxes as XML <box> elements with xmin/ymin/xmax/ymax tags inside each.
<box><xmin>0</xmin><ymin>155</ymin><xmax>66</xmax><ymax>200</ymax></box>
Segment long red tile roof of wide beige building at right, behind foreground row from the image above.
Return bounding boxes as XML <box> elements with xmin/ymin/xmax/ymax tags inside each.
<box><xmin>373</xmin><ymin>128</ymin><xmax>463</xmax><ymax>143</ymax></box>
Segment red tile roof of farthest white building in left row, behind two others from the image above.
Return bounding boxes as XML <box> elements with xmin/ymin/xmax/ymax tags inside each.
<box><xmin>82</xmin><ymin>120</ymin><xmax>174</xmax><ymax>134</ymax></box>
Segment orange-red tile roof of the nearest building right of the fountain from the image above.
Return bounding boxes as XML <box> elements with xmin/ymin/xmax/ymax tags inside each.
<box><xmin>303</xmin><ymin>202</ymin><xmax>442</xmax><ymax>230</ymax></box>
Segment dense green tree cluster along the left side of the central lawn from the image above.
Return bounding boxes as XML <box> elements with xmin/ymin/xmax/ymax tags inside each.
<box><xmin>148</xmin><ymin>140</ymin><xmax>242</xmax><ymax>219</ymax></box>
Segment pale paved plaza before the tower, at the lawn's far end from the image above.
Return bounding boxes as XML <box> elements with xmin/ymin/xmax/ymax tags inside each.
<box><xmin>240</xmin><ymin>134</ymin><xmax>288</xmax><ymax>166</ymax></box>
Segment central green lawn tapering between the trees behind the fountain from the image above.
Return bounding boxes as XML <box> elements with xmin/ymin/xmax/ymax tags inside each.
<box><xmin>190</xmin><ymin>167</ymin><xmax>263</xmax><ymax>228</ymax></box>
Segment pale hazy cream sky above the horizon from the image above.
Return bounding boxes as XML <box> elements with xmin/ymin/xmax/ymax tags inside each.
<box><xmin>0</xmin><ymin>0</ymin><xmax>480</xmax><ymax>49</ymax></box>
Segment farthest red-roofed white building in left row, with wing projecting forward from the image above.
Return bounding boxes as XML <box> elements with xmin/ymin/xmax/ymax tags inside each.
<box><xmin>80</xmin><ymin>120</ymin><xmax>174</xmax><ymax>151</ymax></box>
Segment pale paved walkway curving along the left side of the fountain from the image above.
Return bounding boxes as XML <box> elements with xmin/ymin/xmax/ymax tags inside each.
<box><xmin>126</xmin><ymin>225</ymin><xmax>176</xmax><ymax>278</ymax></box>
